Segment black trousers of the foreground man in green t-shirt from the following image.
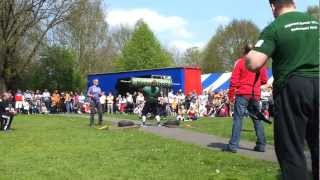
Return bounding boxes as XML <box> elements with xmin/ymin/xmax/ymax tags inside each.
<box><xmin>274</xmin><ymin>76</ymin><xmax>319</xmax><ymax>180</ymax></box>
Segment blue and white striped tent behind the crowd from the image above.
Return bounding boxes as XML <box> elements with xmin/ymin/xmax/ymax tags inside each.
<box><xmin>201</xmin><ymin>69</ymin><xmax>273</xmax><ymax>91</ymax></box>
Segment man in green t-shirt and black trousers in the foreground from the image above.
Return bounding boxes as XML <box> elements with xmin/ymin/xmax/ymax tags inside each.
<box><xmin>246</xmin><ymin>0</ymin><xmax>319</xmax><ymax>180</ymax></box>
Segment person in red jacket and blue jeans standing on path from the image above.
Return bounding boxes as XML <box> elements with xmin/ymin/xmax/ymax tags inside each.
<box><xmin>223</xmin><ymin>44</ymin><xmax>268</xmax><ymax>153</ymax></box>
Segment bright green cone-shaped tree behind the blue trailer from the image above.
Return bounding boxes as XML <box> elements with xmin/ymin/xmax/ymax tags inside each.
<box><xmin>117</xmin><ymin>20</ymin><xmax>172</xmax><ymax>71</ymax></box>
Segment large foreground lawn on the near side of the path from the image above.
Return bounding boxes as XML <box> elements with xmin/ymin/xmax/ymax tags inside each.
<box><xmin>0</xmin><ymin>115</ymin><xmax>279</xmax><ymax>180</ymax></box>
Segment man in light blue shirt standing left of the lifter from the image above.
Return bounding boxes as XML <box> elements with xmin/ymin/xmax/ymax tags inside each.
<box><xmin>87</xmin><ymin>79</ymin><xmax>103</xmax><ymax>126</ymax></box>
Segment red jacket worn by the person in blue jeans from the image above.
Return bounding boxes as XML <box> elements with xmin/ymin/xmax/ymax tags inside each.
<box><xmin>228</xmin><ymin>58</ymin><xmax>268</xmax><ymax>101</ymax></box>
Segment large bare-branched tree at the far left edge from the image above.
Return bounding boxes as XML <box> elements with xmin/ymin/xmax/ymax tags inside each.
<box><xmin>0</xmin><ymin>0</ymin><xmax>75</xmax><ymax>91</ymax></box>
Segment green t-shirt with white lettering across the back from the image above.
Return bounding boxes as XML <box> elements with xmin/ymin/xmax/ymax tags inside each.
<box><xmin>254</xmin><ymin>12</ymin><xmax>319</xmax><ymax>91</ymax></box>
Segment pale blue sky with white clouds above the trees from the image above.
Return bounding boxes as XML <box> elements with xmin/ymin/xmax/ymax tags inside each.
<box><xmin>104</xmin><ymin>0</ymin><xmax>318</xmax><ymax>51</ymax></box>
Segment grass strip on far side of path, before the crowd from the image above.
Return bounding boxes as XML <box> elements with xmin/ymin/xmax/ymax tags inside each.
<box><xmin>105</xmin><ymin>114</ymin><xmax>274</xmax><ymax>145</ymax></box>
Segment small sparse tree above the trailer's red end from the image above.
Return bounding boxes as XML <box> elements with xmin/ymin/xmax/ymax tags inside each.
<box><xmin>183</xmin><ymin>47</ymin><xmax>201</xmax><ymax>66</ymax></box>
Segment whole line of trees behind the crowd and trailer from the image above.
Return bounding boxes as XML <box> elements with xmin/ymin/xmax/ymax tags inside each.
<box><xmin>0</xmin><ymin>0</ymin><xmax>319</xmax><ymax>91</ymax></box>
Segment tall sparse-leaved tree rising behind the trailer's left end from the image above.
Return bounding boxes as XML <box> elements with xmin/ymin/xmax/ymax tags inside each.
<box><xmin>62</xmin><ymin>0</ymin><xmax>117</xmax><ymax>75</ymax></box>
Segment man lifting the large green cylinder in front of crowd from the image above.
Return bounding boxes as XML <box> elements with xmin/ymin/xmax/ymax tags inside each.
<box><xmin>142</xmin><ymin>81</ymin><xmax>160</xmax><ymax>126</ymax></box>
